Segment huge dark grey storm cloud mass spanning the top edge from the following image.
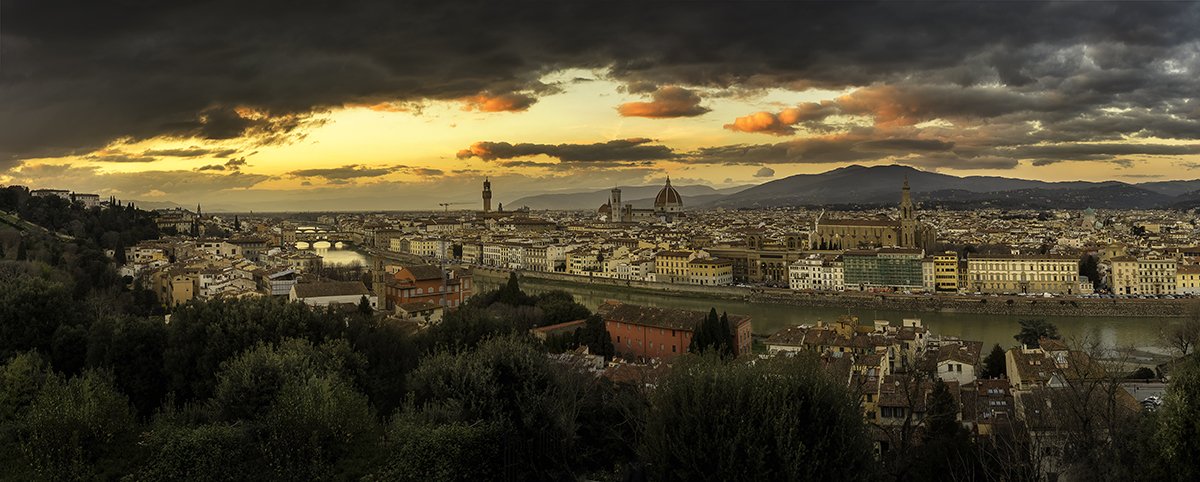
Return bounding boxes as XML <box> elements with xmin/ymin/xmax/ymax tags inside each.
<box><xmin>0</xmin><ymin>0</ymin><xmax>1200</xmax><ymax>167</ymax></box>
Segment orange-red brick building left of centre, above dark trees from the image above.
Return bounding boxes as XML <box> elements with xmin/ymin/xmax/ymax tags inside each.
<box><xmin>384</xmin><ymin>265</ymin><xmax>473</xmax><ymax>309</ymax></box>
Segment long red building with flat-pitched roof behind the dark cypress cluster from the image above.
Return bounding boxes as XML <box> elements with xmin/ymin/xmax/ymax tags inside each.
<box><xmin>596</xmin><ymin>301</ymin><xmax>751</xmax><ymax>360</ymax></box>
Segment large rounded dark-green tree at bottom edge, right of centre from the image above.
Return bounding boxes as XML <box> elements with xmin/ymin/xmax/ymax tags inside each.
<box><xmin>642</xmin><ymin>354</ymin><xmax>875</xmax><ymax>481</ymax></box>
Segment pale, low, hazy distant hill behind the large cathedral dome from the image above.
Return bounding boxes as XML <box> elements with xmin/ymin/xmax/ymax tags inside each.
<box><xmin>513</xmin><ymin>185</ymin><xmax>749</xmax><ymax>210</ymax></box>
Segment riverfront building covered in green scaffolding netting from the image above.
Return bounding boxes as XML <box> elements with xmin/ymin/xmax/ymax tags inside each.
<box><xmin>841</xmin><ymin>248</ymin><xmax>924</xmax><ymax>290</ymax></box>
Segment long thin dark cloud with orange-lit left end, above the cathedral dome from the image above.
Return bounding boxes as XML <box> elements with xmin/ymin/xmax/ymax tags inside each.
<box><xmin>457</xmin><ymin>138</ymin><xmax>676</xmax><ymax>163</ymax></box>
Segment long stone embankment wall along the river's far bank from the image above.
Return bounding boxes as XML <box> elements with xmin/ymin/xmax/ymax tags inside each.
<box><xmin>473</xmin><ymin>267</ymin><xmax>1198</xmax><ymax>318</ymax></box>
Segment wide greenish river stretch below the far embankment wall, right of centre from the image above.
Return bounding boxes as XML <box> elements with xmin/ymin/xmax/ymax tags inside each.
<box><xmin>475</xmin><ymin>277</ymin><xmax>1174</xmax><ymax>362</ymax></box>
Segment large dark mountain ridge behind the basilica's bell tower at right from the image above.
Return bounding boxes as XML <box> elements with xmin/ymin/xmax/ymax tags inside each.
<box><xmin>706</xmin><ymin>165</ymin><xmax>1200</xmax><ymax>209</ymax></box>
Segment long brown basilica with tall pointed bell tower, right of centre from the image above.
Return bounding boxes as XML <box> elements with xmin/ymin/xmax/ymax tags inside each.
<box><xmin>809</xmin><ymin>179</ymin><xmax>934</xmax><ymax>251</ymax></box>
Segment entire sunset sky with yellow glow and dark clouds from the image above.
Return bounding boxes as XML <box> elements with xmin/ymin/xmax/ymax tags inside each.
<box><xmin>0</xmin><ymin>0</ymin><xmax>1200</xmax><ymax>211</ymax></box>
